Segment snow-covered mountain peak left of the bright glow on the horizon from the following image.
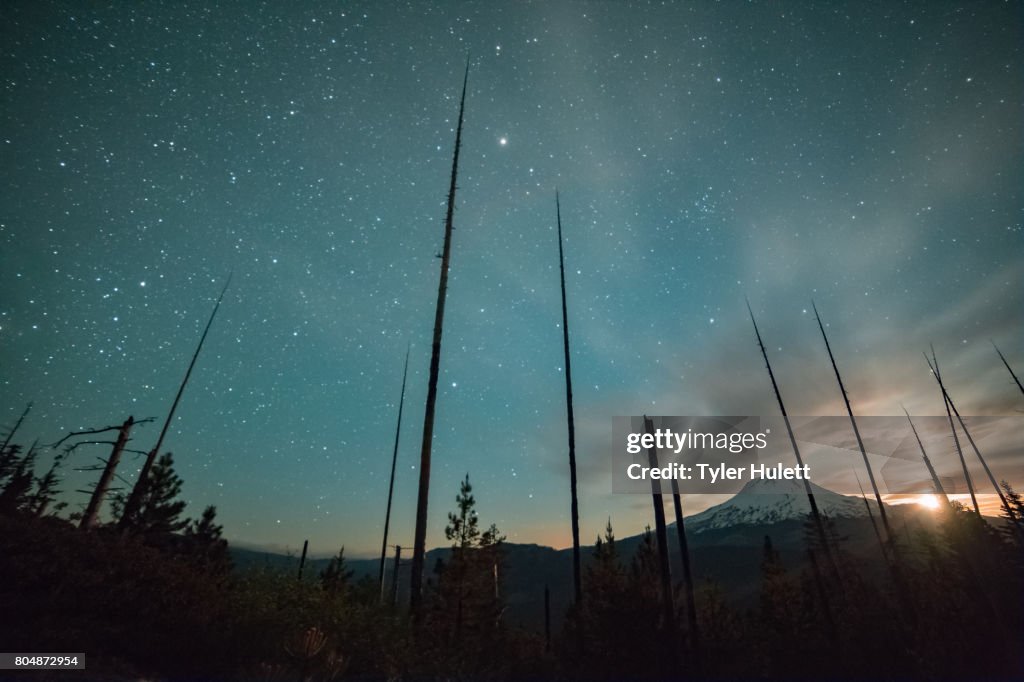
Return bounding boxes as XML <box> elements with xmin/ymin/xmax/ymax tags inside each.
<box><xmin>686</xmin><ymin>479</ymin><xmax>867</xmax><ymax>534</ymax></box>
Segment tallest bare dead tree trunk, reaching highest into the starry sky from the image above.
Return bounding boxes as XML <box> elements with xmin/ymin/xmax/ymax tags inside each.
<box><xmin>410</xmin><ymin>58</ymin><xmax>469</xmax><ymax>620</ymax></box>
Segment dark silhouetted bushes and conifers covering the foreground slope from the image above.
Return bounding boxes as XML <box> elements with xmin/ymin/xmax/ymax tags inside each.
<box><xmin>0</xmin><ymin>432</ymin><xmax>1024</xmax><ymax>680</ymax></box>
